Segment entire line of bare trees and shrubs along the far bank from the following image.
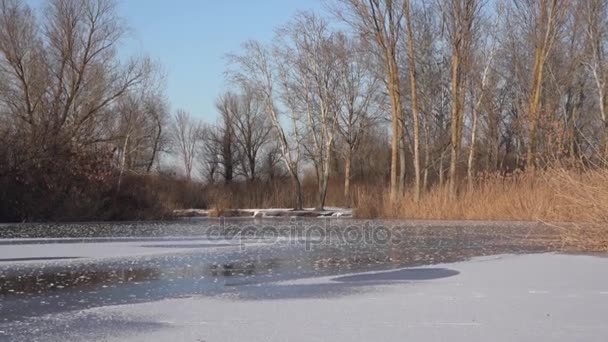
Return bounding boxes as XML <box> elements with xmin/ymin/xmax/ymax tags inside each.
<box><xmin>0</xmin><ymin>0</ymin><xmax>608</xmax><ymax>220</ymax></box>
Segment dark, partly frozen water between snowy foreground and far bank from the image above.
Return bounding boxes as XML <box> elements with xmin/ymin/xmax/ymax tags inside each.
<box><xmin>0</xmin><ymin>219</ymin><xmax>555</xmax><ymax>330</ymax></box>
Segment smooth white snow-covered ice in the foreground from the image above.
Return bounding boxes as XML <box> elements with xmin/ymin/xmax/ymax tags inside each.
<box><xmin>0</xmin><ymin>254</ymin><xmax>608</xmax><ymax>342</ymax></box>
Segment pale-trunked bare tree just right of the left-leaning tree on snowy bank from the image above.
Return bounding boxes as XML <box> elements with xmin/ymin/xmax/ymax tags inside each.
<box><xmin>278</xmin><ymin>12</ymin><xmax>339</xmax><ymax>209</ymax></box>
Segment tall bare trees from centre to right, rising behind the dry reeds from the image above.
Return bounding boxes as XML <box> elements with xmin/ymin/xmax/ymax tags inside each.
<box><xmin>194</xmin><ymin>0</ymin><xmax>608</xmax><ymax>208</ymax></box>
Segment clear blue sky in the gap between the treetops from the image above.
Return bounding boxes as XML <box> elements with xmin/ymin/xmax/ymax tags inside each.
<box><xmin>28</xmin><ymin>0</ymin><xmax>322</xmax><ymax>120</ymax></box>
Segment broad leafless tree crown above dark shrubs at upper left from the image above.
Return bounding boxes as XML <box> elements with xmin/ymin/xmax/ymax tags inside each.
<box><xmin>0</xmin><ymin>0</ymin><xmax>152</xmax><ymax>147</ymax></box>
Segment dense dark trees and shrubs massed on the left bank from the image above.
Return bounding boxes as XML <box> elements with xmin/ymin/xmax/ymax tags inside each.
<box><xmin>0</xmin><ymin>0</ymin><xmax>173</xmax><ymax>221</ymax></box>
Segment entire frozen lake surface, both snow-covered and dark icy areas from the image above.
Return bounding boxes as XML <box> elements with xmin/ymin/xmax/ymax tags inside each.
<box><xmin>0</xmin><ymin>219</ymin><xmax>608</xmax><ymax>341</ymax></box>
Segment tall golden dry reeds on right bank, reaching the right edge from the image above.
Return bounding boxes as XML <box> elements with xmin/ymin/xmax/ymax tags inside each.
<box><xmin>355</xmin><ymin>169</ymin><xmax>608</xmax><ymax>251</ymax></box>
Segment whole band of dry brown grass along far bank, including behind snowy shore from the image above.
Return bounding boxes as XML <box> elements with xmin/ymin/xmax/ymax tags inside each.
<box><xmin>170</xmin><ymin>169</ymin><xmax>608</xmax><ymax>251</ymax></box>
